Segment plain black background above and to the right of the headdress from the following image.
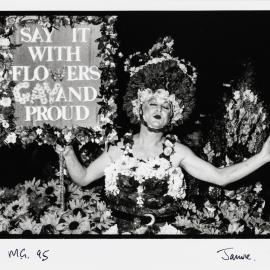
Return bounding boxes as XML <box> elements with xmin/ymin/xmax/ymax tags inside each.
<box><xmin>117</xmin><ymin>11</ymin><xmax>270</xmax><ymax>116</ymax></box>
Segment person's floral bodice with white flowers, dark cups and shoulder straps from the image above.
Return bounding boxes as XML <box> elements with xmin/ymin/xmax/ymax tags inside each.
<box><xmin>105</xmin><ymin>134</ymin><xmax>186</xmax><ymax>216</ymax></box>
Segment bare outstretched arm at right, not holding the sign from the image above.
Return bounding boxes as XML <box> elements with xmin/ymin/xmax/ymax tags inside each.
<box><xmin>176</xmin><ymin>138</ymin><xmax>270</xmax><ymax>186</ymax></box>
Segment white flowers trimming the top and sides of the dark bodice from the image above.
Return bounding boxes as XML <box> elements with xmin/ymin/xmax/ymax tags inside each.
<box><xmin>105</xmin><ymin>133</ymin><xmax>186</xmax><ymax>207</ymax></box>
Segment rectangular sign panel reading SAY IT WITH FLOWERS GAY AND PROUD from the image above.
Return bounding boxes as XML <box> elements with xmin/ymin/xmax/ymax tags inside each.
<box><xmin>12</xmin><ymin>24</ymin><xmax>101</xmax><ymax>128</ymax></box>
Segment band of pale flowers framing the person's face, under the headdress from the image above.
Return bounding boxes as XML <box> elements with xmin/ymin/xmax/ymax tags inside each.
<box><xmin>132</xmin><ymin>88</ymin><xmax>184</xmax><ymax>124</ymax></box>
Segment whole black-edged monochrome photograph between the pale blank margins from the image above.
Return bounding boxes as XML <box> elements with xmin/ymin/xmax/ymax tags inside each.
<box><xmin>0</xmin><ymin>5</ymin><xmax>270</xmax><ymax>243</ymax></box>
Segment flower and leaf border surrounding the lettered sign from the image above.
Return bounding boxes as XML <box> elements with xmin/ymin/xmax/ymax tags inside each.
<box><xmin>0</xmin><ymin>15</ymin><xmax>122</xmax><ymax>150</ymax></box>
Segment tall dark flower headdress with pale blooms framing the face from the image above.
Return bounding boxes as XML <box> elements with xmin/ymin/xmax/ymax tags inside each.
<box><xmin>124</xmin><ymin>37</ymin><xmax>197</xmax><ymax>125</ymax></box>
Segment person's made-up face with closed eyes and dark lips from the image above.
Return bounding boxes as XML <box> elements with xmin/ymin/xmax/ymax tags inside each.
<box><xmin>142</xmin><ymin>97</ymin><xmax>171</xmax><ymax>129</ymax></box>
